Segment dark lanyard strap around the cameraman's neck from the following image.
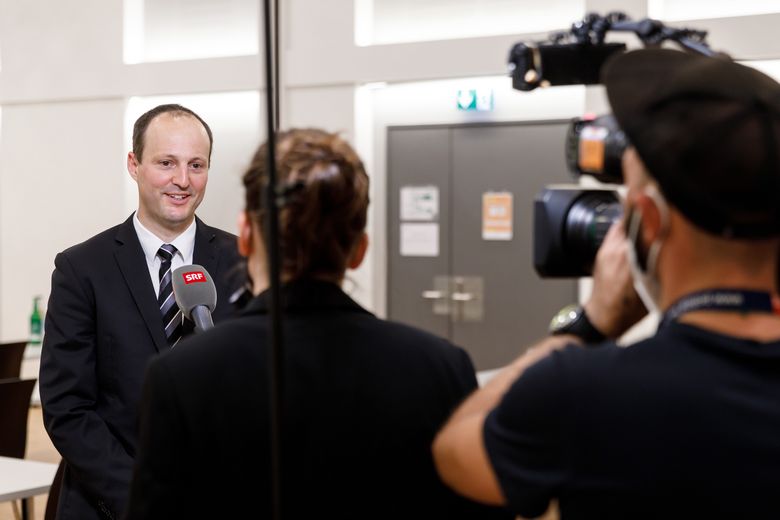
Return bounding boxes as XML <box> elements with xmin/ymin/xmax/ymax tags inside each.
<box><xmin>660</xmin><ymin>289</ymin><xmax>780</xmax><ymax>326</ymax></box>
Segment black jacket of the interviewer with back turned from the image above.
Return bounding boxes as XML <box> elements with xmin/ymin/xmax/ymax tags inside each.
<box><xmin>127</xmin><ymin>280</ymin><xmax>507</xmax><ymax>520</ymax></box>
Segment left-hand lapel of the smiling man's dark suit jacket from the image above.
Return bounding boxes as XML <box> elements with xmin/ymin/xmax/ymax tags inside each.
<box><xmin>114</xmin><ymin>216</ymin><xmax>168</xmax><ymax>352</ymax></box>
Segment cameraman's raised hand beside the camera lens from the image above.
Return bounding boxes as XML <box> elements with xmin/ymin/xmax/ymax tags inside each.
<box><xmin>585</xmin><ymin>220</ymin><xmax>647</xmax><ymax>339</ymax></box>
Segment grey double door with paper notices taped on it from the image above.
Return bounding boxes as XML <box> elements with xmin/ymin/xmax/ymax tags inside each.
<box><xmin>387</xmin><ymin>121</ymin><xmax>577</xmax><ymax>370</ymax></box>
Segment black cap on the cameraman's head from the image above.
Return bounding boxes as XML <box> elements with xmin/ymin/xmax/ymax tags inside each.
<box><xmin>602</xmin><ymin>49</ymin><xmax>780</xmax><ymax>238</ymax></box>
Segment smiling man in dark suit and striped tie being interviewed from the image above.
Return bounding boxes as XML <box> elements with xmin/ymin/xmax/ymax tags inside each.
<box><xmin>40</xmin><ymin>105</ymin><xmax>243</xmax><ymax>520</ymax></box>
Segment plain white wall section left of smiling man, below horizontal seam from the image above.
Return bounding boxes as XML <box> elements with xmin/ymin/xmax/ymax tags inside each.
<box><xmin>0</xmin><ymin>99</ymin><xmax>127</xmax><ymax>340</ymax></box>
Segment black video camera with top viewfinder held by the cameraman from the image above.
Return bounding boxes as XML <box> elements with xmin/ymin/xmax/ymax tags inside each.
<box><xmin>509</xmin><ymin>12</ymin><xmax>715</xmax><ymax>278</ymax></box>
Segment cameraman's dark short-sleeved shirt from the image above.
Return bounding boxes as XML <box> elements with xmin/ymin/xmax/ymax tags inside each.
<box><xmin>484</xmin><ymin>323</ymin><xmax>780</xmax><ymax>519</ymax></box>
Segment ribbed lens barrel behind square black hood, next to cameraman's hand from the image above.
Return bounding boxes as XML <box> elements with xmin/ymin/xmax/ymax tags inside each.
<box><xmin>564</xmin><ymin>191</ymin><xmax>623</xmax><ymax>273</ymax></box>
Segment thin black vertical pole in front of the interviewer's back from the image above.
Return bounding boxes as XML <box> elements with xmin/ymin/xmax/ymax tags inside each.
<box><xmin>260</xmin><ymin>0</ymin><xmax>284</xmax><ymax>520</ymax></box>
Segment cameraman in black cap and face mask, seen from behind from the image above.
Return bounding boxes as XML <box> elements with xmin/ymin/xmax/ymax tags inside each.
<box><xmin>434</xmin><ymin>49</ymin><xmax>780</xmax><ymax>518</ymax></box>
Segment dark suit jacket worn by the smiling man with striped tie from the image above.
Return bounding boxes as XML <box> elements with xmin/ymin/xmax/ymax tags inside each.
<box><xmin>40</xmin><ymin>216</ymin><xmax>244</xmax><ymax>520</ymax></box>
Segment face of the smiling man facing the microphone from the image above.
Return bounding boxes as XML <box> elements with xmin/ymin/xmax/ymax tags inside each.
<box><xmin>127</xmin><ymin>112</ymin><xmax>210</xmax><ymax>242</ymax></box>
